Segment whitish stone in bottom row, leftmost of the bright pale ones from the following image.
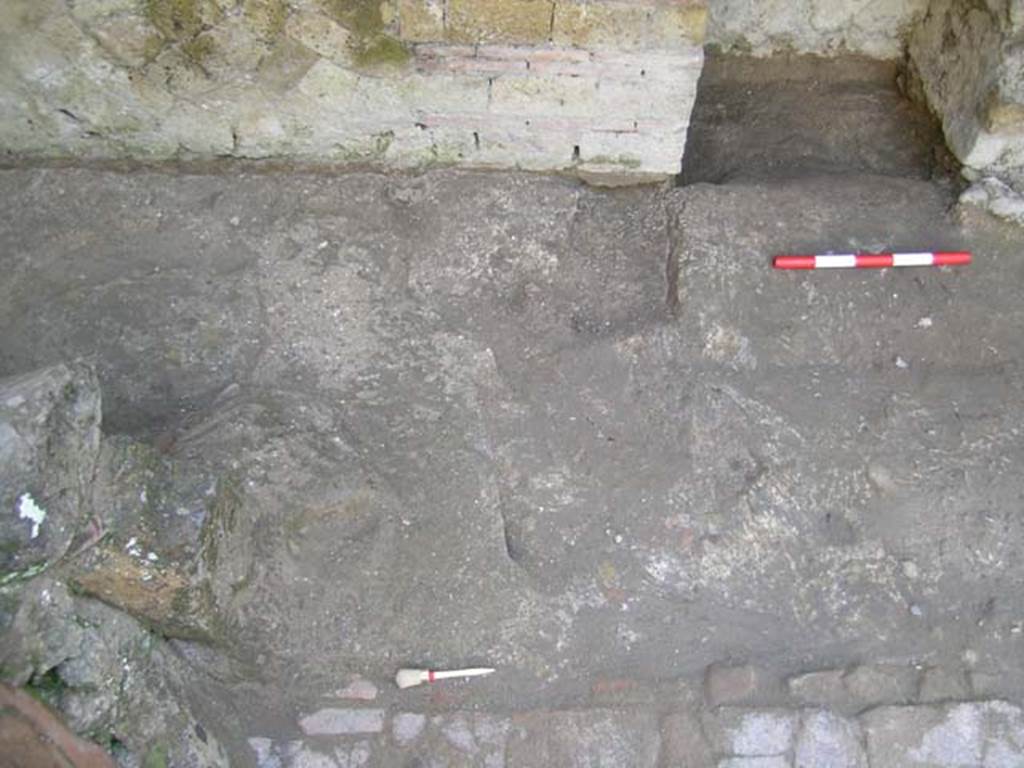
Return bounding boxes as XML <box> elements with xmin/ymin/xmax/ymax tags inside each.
<box><xmin>702</xmin><ymin>707</ymin><xmax>800</xmax><ymax>757</ymax></box>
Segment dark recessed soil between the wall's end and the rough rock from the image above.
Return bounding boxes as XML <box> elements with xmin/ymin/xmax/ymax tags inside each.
<box><xmin>680</xmin><ymin>53</ymin><xmax>951</xmax><ymax>184</ymax></box>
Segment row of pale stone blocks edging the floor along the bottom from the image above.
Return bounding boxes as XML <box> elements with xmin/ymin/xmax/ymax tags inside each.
<box><xmin>237</xmin><ymin>663</ymin><xmax>1024</xmax><ymax>768</ymax></box>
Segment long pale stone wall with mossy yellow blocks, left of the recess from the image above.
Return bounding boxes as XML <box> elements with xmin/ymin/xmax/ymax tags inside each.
<box><xmin>0</xmin><ymin>0</ymin><xmax>707</xmax><ymax>178</ymax></box>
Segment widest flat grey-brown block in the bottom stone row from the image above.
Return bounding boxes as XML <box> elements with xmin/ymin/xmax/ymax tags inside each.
<box><xmin>506</xmin><ymin>710</ymin><xmax>660</xmax><ymax>768</ymax></box>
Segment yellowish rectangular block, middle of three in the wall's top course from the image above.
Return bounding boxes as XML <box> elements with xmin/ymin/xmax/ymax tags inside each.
<box><xmin>447</xmin><ymin>0</ymin><xmax>554</xmax><ymax>44</ymax></box>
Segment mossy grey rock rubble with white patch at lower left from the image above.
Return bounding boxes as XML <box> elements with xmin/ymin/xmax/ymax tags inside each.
<box><xmin>0</xmin><ymin>362</ymin><xmax>227</xmax><ymax>766</ymax></box>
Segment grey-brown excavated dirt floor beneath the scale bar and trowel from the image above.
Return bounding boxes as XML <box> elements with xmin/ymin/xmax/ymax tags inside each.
<box><xmin>0</xmin><ymin>57</ymin><xmax>1024</xmax><ymax>761</ymax></box>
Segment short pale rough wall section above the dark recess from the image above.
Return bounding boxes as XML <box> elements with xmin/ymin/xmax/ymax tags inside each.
<box><xmin>708</xmin><ymin>0</ymin><xmax>928</xmax><ymax>58</ymax></box>
